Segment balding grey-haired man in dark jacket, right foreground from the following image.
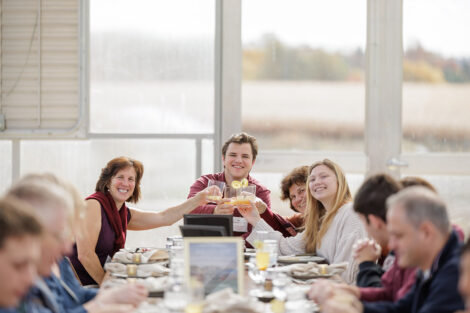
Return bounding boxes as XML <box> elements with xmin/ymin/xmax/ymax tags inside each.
<box><xmin>363</xmin><ymin>187</ymin><xmax>464</xmax><ymax>313</ymax></box>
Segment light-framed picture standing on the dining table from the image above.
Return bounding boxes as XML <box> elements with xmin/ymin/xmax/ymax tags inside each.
<box><xmin>183</xmin><ymin>237</ymin><xmax>245</xmax><ymax>295</ymax></box>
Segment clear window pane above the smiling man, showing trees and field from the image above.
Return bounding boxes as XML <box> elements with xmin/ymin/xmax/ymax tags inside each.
<box><xmin>242</xmin><ymin>0</ymin><xmax>367</xmax><ymax>152</ymax></box>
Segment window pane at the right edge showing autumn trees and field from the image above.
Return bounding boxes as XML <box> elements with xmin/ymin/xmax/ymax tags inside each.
<box><xmin>403</xmin><ymin>0</ymin><xmax>470</xmax><ymax>153</ymax></box>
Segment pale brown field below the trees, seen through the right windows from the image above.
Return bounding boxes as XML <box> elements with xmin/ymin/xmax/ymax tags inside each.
<box><xmin>242</xmin><ymin>81</ymin><xmax>470</xmax><ymax>152</ymax></box>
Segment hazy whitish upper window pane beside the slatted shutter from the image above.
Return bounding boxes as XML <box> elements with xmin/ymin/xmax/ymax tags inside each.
<box><xmin>90</xmin><ymin>0</ymin><xmax>215</xmax><ymax>133</ymax></box>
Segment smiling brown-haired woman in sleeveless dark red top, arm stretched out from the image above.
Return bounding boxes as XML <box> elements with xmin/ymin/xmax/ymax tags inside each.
<box><xmin>70</xmin><ymin>157</ymin><xmax>220</xmax><ymax>285</ymax></box>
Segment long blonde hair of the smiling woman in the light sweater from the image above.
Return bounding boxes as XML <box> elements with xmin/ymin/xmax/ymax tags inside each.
<box><xmin>304</xmin><ymin>159</ymin><xmax>352</xmax><ymax>253</ymax></box>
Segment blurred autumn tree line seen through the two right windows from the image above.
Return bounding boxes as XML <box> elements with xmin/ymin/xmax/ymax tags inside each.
<box><xmin>243</xmin><ymin>34</ymin><xmax>470</xmax><ymax>83</ymax></box>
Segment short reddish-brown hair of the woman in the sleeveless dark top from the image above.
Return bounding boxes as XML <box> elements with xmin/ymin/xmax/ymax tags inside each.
<box><xmin>95</xmin><ymin>156</ymin><xmax>144</xmax><ymax>203</ymax></box>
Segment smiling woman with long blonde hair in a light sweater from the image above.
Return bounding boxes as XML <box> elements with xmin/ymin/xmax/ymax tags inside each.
<box><xmin>239</xmin><ymin>159</ymin><xmax>367</xmax><ymax>284</ymax></box>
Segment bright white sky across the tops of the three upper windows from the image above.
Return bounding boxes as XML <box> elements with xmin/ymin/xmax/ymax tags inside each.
<box><xmin>90</xmin><ymin>0</ymin><xmax>470</xmax><ymax>57</ymax></box>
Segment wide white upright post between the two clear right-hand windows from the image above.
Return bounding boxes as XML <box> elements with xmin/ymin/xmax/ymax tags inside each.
<box><xmin>365</xmin><ymin>0</ymin><xmax>403</xmax><ymax>176</ymax></box>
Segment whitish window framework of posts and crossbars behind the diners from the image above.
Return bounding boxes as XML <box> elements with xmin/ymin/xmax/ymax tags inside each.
<box><xmin>1</xmin><ymin>0</ymin><xmax>470</xmax><ymax>185</ymax></box>
